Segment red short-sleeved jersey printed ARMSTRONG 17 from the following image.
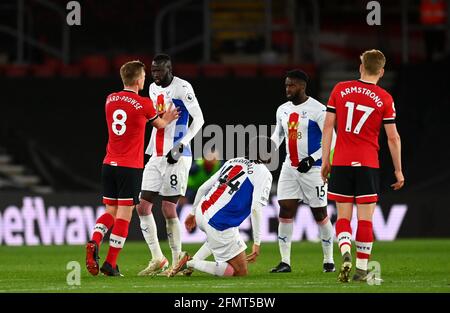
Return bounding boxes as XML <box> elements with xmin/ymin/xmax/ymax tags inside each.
<box><xmin>327</xmin><ymin>80</ymin><xmax>395</xmax><ymax>168</ymax></box>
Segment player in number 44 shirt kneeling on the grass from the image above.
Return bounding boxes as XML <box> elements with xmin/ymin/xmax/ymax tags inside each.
<box><xmin>169</xmin><ymin>152</ymin><xmax>272</xmax><ymax>276</ymax></box>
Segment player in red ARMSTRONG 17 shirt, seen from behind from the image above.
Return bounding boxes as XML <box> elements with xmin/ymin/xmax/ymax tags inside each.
<box><xmin>322</xmin><ymin>50</ymin><xmax>405</xmax><ymax>282</ymax></box>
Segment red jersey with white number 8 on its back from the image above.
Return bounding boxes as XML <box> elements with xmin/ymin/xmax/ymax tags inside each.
<box><xmin>103</xmin><ymin>90</ymin><xmax>158</xmax><ymax>169</ymax></box>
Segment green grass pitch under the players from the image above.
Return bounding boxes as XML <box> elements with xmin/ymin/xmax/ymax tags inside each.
<box><xmin>0</xmin><ymin>239</ymin><xmax>450</xmax><ymax>293</ymax></box>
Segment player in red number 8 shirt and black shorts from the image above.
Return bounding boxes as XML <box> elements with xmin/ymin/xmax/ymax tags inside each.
<box><xmin>86</xmin><ymin>61</ymin><xmax>178</xmax><ymax>276</ymax></box>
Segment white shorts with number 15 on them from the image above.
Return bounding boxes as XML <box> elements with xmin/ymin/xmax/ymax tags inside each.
<box><xmin>277</xmin><ymin>162</ymin><xmax>327</xmax><ymax>208</ymax></box>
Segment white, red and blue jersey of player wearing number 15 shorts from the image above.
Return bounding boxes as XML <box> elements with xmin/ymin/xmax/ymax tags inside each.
<box><xmin>271</xmin><ymin>97</ymin><xmax>335</xmax><ymax>167</ymax></box>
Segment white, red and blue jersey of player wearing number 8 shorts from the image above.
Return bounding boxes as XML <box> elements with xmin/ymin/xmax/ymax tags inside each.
<box><xmin>145</xmin><ymin>76</ymin><xmax>203</xmax><ymax>156</ymax></box>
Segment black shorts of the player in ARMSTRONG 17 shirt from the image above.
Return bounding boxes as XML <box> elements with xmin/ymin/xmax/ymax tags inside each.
<box><xmin>328</xmin><ymin>166</ymin><xmax>380</xmax><ymax>203</ymax></box>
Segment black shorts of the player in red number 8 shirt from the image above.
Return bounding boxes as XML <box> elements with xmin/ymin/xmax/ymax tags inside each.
<box><xmin>102</xmin><ymin>164</ymin><xmax>142</xmax><ymax>206</ymax></box>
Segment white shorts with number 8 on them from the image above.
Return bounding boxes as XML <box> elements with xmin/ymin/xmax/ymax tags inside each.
<box><xmin>141</xmin><ymin>156</ymin><xmax>192</xmax><ymax>197</ymax></box>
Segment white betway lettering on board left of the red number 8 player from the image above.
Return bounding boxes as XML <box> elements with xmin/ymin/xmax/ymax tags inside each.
<box><xmin>0</xmin><ymin>197</ymin><xmax>105</xmax><ymax>246</ymax></box>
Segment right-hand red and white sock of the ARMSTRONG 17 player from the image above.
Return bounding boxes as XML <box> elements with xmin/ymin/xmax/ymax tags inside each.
<box><xmin>356</xmin><ymin>220</ymin><xmax>373</xmax><ymax>271</ymax></box>
